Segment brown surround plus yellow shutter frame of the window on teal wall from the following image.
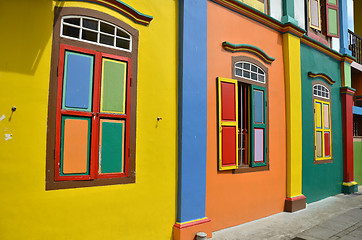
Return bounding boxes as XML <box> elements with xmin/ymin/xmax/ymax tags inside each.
<box><xmin>312</xmin><ymin>81</ymin><xmax>333</xmax><ymax>164</ymax></box>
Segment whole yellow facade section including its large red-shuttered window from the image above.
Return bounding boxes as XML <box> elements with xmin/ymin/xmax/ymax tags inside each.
<box><xmin>0</xmin><ymin>0</ymin><xmax>177</xmax><ymax>239</ymax></box>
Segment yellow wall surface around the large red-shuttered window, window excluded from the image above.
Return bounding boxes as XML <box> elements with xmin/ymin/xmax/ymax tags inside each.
<box><xmin>0</xmin><ymin>0</ymin><xmax>178</xmax><ymax>240</ymax></box>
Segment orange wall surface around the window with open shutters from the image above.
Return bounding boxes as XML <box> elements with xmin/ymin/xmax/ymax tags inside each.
<box><xmin>206</xmin><ymin>1</ymin><xmax>286</xmax><ymax>231</ymax></box>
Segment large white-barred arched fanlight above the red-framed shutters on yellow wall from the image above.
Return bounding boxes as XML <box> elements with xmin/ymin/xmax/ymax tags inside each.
<box><xmin>60</xmin><ymin>16</ymin><xmax>132</xmax><ymax>52</ymax></box>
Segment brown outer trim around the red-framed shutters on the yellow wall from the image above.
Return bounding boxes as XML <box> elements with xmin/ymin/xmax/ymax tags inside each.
<box><xmin>46</xmin><ymin>7</ymin><xmax>139</xmax><ymax>190</ymax></box>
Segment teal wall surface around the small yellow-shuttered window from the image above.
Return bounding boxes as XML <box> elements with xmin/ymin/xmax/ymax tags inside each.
<box><xmin>301</xmin><ymin>44</ymin><xmax>343</xmax><ymax>203</ymax></box>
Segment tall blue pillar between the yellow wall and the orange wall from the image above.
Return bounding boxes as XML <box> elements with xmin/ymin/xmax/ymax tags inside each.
<box><xmin>177</xmin><ymin>0</ymin><xmax>207</xmax><ymax>226</ymax></box>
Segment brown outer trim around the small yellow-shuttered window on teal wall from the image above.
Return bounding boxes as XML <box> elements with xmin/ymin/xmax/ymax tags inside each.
<box><xmin>312</xmin><ymin>80</ymin><xmax>333</xmax><ymax>164</ymax></box>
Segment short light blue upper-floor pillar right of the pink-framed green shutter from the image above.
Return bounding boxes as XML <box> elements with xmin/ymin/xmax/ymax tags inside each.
<box><xmin>339</xmin><ymin>0</ymin><xmax>352</xmax><ymax>56</ymax></box>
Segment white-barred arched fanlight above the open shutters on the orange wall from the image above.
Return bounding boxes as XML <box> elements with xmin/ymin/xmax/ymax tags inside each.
<box><xmin>235</xmin><ymin>61</ymin><xmax>265</xmax><ymax>83</ymax></box>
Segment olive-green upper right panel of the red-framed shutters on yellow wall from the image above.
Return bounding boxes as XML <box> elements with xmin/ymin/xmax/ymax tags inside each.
<box><xmin>101</xmin><ymin>58</ymin><xmax>127</xmax><ymax>114</ymax></box>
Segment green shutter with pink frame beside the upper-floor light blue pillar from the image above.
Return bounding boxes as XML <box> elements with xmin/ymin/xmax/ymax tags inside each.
<box><xmin>326</xmin><ymin>0</ymin><xmax>339</xmax><ymax>37</ymax></box>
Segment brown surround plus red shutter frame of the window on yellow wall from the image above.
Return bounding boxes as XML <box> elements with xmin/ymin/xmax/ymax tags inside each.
<box><xmin>46</xmin><ymin>7</ymin><xmax>138</xmax><ymax>190</ymax></box>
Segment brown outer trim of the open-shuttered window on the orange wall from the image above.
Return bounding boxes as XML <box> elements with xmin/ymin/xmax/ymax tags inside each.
<box><xmin>231</xmin><ymin>56</ymin><xmax>269</xmax><ymax>174</ymax></box>
